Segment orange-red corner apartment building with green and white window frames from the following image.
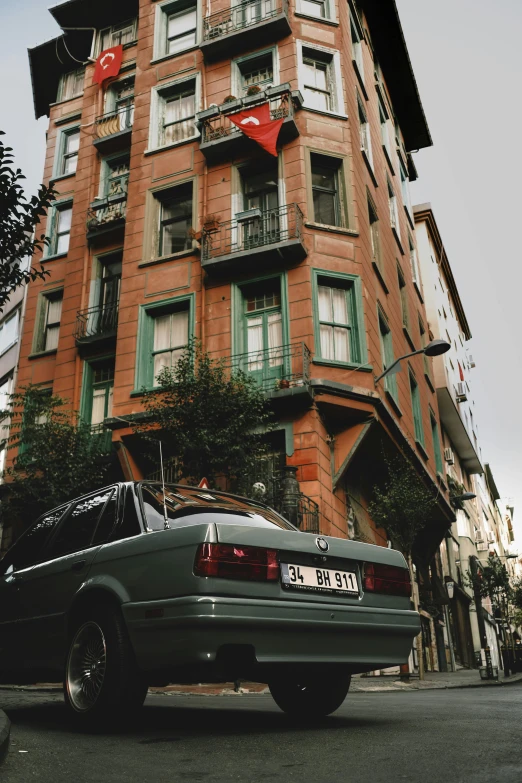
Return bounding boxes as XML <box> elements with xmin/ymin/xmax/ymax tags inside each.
<box><xmin>19</xmin><ymin>0</ymin><xmax>452</xmax><ymax>554</ymax></box>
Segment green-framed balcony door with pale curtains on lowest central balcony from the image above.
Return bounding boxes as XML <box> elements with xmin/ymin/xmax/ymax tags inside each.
<box><xmin>242</xmin><ymin>279</ymin><xmax>284</xmax><ymax>388</ymax></box>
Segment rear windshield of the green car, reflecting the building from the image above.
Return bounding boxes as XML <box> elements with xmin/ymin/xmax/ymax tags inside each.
<box><xmin>141</xmin><ymin>485</ymin><xmax>295</xmax><ymax>530</ymax></box>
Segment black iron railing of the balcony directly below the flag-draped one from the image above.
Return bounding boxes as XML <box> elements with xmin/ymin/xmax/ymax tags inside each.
<box><xmin>201</xmin><ymin>204</ymin><xmax>303</xmax><ymax>261</ymax></box>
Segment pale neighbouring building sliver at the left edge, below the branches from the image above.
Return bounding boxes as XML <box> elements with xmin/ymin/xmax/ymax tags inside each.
<box><xmin>0</xmin><ymin>270</ymin><xmax>27</xmax><ymax>553</ymax></box>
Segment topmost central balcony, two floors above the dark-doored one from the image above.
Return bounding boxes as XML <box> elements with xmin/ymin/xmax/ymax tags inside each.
<box><xmin>201</xmin><ymin>0</ymin><xmax>291</xmax><ymax>62</ymax></box>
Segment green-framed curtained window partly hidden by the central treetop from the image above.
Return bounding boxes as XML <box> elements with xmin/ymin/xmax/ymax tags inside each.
<box><xmin>133</xmin><ymin>293</ymin><xmax>196</xmax><ymax>393</ymax></box>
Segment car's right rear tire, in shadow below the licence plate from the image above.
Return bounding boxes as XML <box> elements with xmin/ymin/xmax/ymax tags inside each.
<box><xmin>268</xmin><ymin>672</ymin><xmax>351</xmax><ymax>719</ymax></box>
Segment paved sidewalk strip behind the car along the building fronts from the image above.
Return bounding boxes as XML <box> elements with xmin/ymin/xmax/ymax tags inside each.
<box><xmin>4</xmin><ymin>669</ymin><xmax>522</xmax><ymax>696</ymax></box>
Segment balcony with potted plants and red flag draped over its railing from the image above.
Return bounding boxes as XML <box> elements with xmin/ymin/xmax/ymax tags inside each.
<box><xmin>196</xmin><ymin>84</ymin><xmax>303</xmax><ymax>164</ymax></box>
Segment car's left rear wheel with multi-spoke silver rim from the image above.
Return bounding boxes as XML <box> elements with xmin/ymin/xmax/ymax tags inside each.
<box><xmin>64</xmin><ymin>608</ymin><xmax>147</xmax><ymax>727</ymax></box>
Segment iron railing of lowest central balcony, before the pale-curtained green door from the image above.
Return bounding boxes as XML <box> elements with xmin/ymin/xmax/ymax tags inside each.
<box><xmin>218</xmin><ymin>342</ymin><xmax>311</xmax><ymax>393</ymax></box>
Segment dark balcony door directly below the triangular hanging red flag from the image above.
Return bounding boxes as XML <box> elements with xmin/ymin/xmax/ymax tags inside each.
<box><xmin>242</xmin><ymin>161</ymin><xmax>281</xmax><ymax>249</ymax></box>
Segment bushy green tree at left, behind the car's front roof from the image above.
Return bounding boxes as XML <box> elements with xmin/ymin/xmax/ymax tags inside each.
<box><xmin>2</xmin><ymin>386</ymin><xmax>109</xmax><ymax>533</ymax></box>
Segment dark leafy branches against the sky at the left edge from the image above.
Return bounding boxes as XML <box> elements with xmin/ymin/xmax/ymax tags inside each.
<box><xmin>0</xmin><ymin>131</ymin><xmax>55</xmax><ymax>312</ymax></box>
